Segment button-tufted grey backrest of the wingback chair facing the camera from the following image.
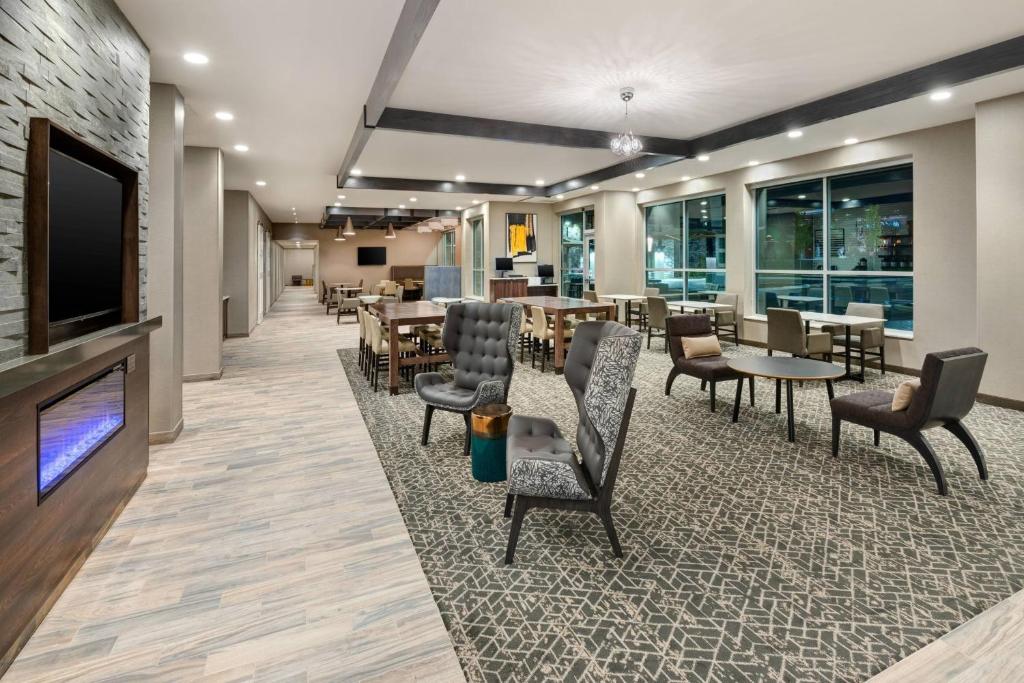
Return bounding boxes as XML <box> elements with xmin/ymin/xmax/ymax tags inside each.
<box><xmin>441</xmin><ymin>301</ymin><xmax>522</xmax><ymax>398</ymax></box>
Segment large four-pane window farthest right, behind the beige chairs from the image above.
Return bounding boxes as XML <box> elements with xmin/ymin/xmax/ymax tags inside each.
<box><xmin>755</xmin><ymin>165</ymin><xmax>913</xmax><ymax>331</ymax></box>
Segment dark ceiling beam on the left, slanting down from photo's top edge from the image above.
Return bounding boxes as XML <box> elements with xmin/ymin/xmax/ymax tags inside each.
<box><xmin>338</xmin><ymin>0</ymin><xmax>440</xmax><ymax>180</ymax></box>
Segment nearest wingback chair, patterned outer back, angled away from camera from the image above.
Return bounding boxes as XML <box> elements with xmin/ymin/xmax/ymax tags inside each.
<box><xmin>505</xmin><ymin>321</ymin><xmax>641</xmax><ymax>564</ymax></box>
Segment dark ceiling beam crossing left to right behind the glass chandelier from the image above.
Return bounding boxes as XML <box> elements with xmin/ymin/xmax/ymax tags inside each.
<box><xmin>376</xmin><ymin>106</ymin><xmax>690</xmax><ymax>157</ymax></box>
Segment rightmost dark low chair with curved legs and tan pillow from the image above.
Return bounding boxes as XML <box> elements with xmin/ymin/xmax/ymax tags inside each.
<box><xmin>830</xmin><ymin>347</ymin><xmax>988</xmax><ymax>496</ymax></box>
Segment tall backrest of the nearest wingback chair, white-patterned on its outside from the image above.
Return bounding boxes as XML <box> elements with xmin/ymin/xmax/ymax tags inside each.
<box><xmin>565</xmin><ymin>321</ymin><xmax>641</xmax><ymax>496</ymax></box>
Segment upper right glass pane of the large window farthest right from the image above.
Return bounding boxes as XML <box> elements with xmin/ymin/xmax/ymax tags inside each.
<box><xmin>828</xmin><ymin>166</ymin><xmax>913</xmax><ymax>271</ymax></box>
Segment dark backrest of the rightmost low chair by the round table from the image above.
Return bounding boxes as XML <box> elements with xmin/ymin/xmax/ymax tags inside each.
<box><xmin>907</xmin><ymin>347</ymin><xmax>988</xmax><ymax>428</ymax></box>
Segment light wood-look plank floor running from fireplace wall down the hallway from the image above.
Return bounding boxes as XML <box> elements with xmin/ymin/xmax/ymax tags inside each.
<box><xmin>4</xmin><ymin>288</ymin><xmax>463</xmax><ymax>683</ymax></box>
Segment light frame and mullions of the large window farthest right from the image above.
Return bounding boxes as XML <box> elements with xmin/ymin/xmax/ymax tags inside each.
<box><xmin>753</xmin><ymin>158</ymin><xmax>918</xmax><ymax>331</ymax></box>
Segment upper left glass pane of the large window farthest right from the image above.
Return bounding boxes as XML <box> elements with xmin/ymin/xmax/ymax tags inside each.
<box><xmin>756</xmin><ymin>180</ymin><xmax>824</xmax><ymax>270</ymax></box>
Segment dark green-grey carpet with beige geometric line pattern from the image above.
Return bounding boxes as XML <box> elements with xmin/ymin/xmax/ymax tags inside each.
<box><xmin>339</xmin><ymin>340</ymin><xmax>1024</xmax><ymax>681</ymax></box>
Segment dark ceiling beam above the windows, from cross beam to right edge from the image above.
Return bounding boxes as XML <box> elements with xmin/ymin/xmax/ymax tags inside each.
<box><xmin>690</xmin><ymin>36</ymin><xmax>1024</xmax><ymax>155</ymax></box>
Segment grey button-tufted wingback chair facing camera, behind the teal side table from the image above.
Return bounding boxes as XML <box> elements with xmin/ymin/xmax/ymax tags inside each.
<box><xmin>415</xmin><ymin>302</ymin><xmax>522</xmax><ymax>455</ymax></box>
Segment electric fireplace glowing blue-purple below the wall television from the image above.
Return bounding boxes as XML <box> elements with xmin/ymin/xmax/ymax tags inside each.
<box><xmin>37</xmin><ymin>360</ymin><xmax>125</xmax><ymax>502</ymax></box>
